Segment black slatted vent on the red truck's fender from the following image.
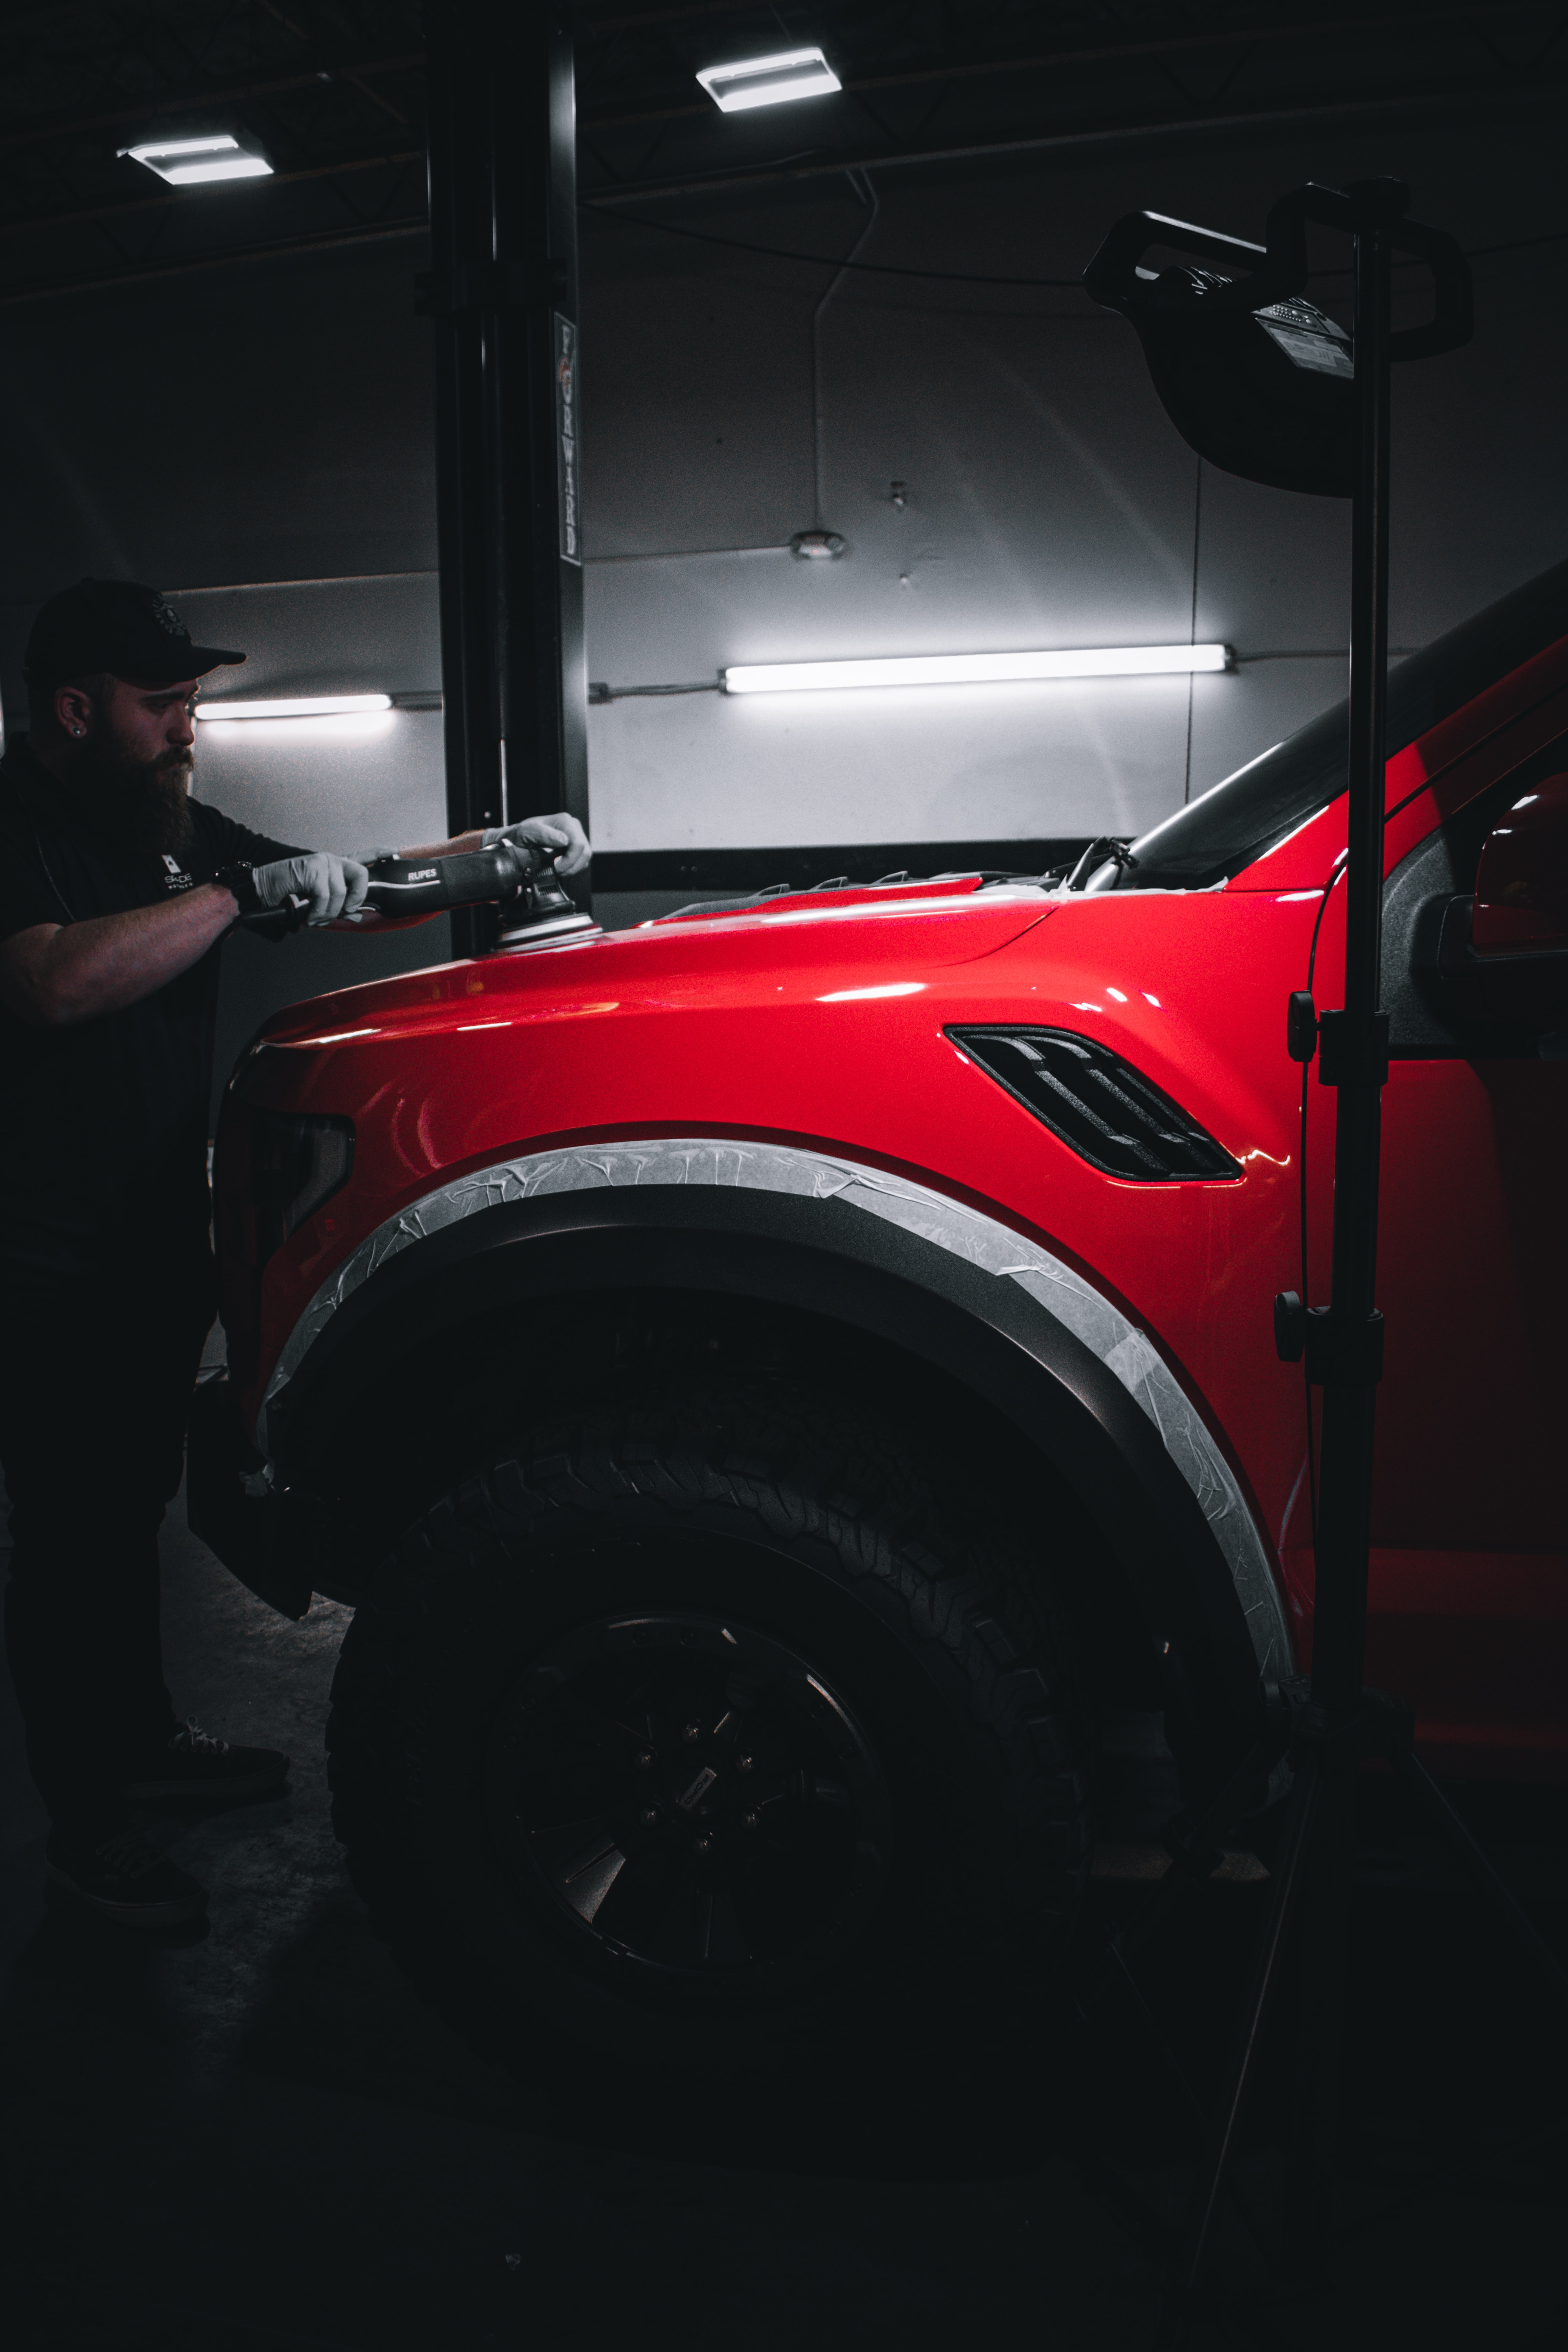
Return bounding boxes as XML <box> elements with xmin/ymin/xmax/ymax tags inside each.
<box><xmin>947</xmin><ymin>1028</ymin><xmax>1241</xmax><ymax>1183</ymax></box>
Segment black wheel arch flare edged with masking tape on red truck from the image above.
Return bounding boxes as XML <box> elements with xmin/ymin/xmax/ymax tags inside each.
<box><xmin>259</xmin><ymin>1138</ymin><xmax>1290</xmax><ymax>1722</ymax></box>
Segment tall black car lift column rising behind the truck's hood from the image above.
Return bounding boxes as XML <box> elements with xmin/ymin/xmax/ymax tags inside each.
<box><xmin>423</xmin><ymin>0</ymin><xmax>588</xmax><ymax>955</ymax></box>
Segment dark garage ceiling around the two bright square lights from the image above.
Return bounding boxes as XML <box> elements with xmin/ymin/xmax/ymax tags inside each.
<box><xmin>0</xmin><ymin>0</ymin><xmax>1568</xmax><ymax>301</ymax></box>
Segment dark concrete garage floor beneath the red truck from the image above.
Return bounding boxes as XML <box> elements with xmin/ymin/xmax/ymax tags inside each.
<box><xmin>0</xmin><ymin>1468</ymin><xmax>1568</xmax><ymax>2352</ymax></box>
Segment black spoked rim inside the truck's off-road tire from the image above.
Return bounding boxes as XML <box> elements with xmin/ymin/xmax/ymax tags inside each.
<box><xmin>486</xmin><ymin>1611</ymin><xmax>891</xmax><ymax>1999</ymax></box>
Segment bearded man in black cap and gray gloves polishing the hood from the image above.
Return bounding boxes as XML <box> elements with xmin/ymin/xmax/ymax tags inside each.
<box><xmin>0</xmin><ymin>579</ymin><xmax>590</xmax><ymax>1926</ymax></box>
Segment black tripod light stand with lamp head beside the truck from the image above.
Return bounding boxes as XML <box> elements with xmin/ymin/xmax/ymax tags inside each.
<box><xmin>1084</xmin><ymin>179</ymin><xmax>1568</xmax><ymax>2347</ymax></box>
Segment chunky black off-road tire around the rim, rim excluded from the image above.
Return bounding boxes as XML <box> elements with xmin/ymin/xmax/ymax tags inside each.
<box><xmin>327</xmin><ymin>1383</ymin><xmax>1091</xmax><ymax>2067</ymax></box>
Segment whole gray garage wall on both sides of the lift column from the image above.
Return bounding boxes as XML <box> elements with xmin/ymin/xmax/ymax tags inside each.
<box><xmin>0</xmin><ymin>127</ymin><xmax>1568</xmax><ymax>1082</ymax></box>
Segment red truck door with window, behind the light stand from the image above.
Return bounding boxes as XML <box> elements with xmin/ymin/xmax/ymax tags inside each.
<box><xmin>1307</xmin><ymin>741</ymin><xmax>1568</xmax><ymax>1776</ymax></box>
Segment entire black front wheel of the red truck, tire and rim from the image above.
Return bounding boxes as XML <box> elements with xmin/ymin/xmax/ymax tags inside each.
<box><xmin>329</xmin><ymin>1395</ymin><xmax>1089</xmax><ymax>2063</ymax></box>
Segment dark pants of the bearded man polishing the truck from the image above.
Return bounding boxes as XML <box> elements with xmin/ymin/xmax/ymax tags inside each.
<box><xmin>0</xmin><ymin>1244</ymin><xmax>216</xmax><ymax>1842</ymax></box>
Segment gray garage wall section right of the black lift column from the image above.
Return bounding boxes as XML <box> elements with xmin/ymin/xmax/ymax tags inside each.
<box><xmin>583</xmin><ymin>129</ymin><xmax>1568</xmax><ymax>847</ymax></box>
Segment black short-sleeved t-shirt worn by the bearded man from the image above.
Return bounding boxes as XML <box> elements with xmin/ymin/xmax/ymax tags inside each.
<box><xmin>0</xmin><ymin>739</ymin><xmax>301</xmax><ymax>1279</ymax></box>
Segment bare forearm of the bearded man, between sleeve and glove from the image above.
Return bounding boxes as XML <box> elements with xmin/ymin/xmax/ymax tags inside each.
<box><xmin>0</xmin><ymin>882</ymin><xmax>240</xmax><ymax>1028</ymax></box>
